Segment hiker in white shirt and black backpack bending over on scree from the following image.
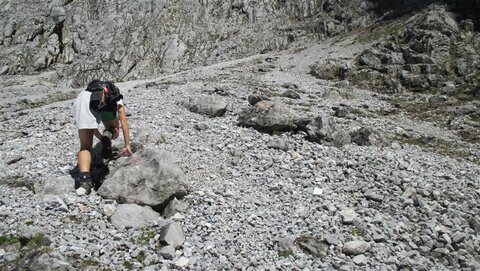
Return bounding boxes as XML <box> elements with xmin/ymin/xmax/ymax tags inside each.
<box><xmin>74</xmin><ymin>80</ymin><xmax>132</xmax><ymax>193</ymax></box>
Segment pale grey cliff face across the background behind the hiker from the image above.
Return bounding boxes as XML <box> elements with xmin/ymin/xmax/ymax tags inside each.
<box><xmin>0</xmin><ymin>0</ymin><xmax>374</xmax><ymax>86</ymax></box>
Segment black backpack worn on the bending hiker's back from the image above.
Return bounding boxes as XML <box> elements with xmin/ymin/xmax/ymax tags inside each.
<box><xmin>86</xmin><ymin>80</ymin><xmax>123</xmax><ymax>112</ymax></box>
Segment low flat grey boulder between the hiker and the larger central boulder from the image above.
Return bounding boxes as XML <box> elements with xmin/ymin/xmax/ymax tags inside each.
<box><xmin>182</xmin><ymin>95</ymin><xmax>228</xmax><ymax>118</ymax></box>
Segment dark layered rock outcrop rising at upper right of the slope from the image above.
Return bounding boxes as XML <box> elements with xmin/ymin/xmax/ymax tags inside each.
<box><xmin>350</xmin><ymin>6</ymin><xmax>480</xmax><ymax>95</ymax></box>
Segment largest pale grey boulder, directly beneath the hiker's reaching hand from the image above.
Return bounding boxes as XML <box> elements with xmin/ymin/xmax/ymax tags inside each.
<box><xmin>98</xmin><ymin>150</ymin><xmax>188</xmax><ymax>210</ymax></box>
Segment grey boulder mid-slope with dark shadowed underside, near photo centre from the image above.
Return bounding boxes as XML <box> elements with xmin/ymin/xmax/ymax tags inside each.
<box><xmin>238</xmin><ymin>101</ymin><xmax>296</xmax><ymax>133</ymax></box>
